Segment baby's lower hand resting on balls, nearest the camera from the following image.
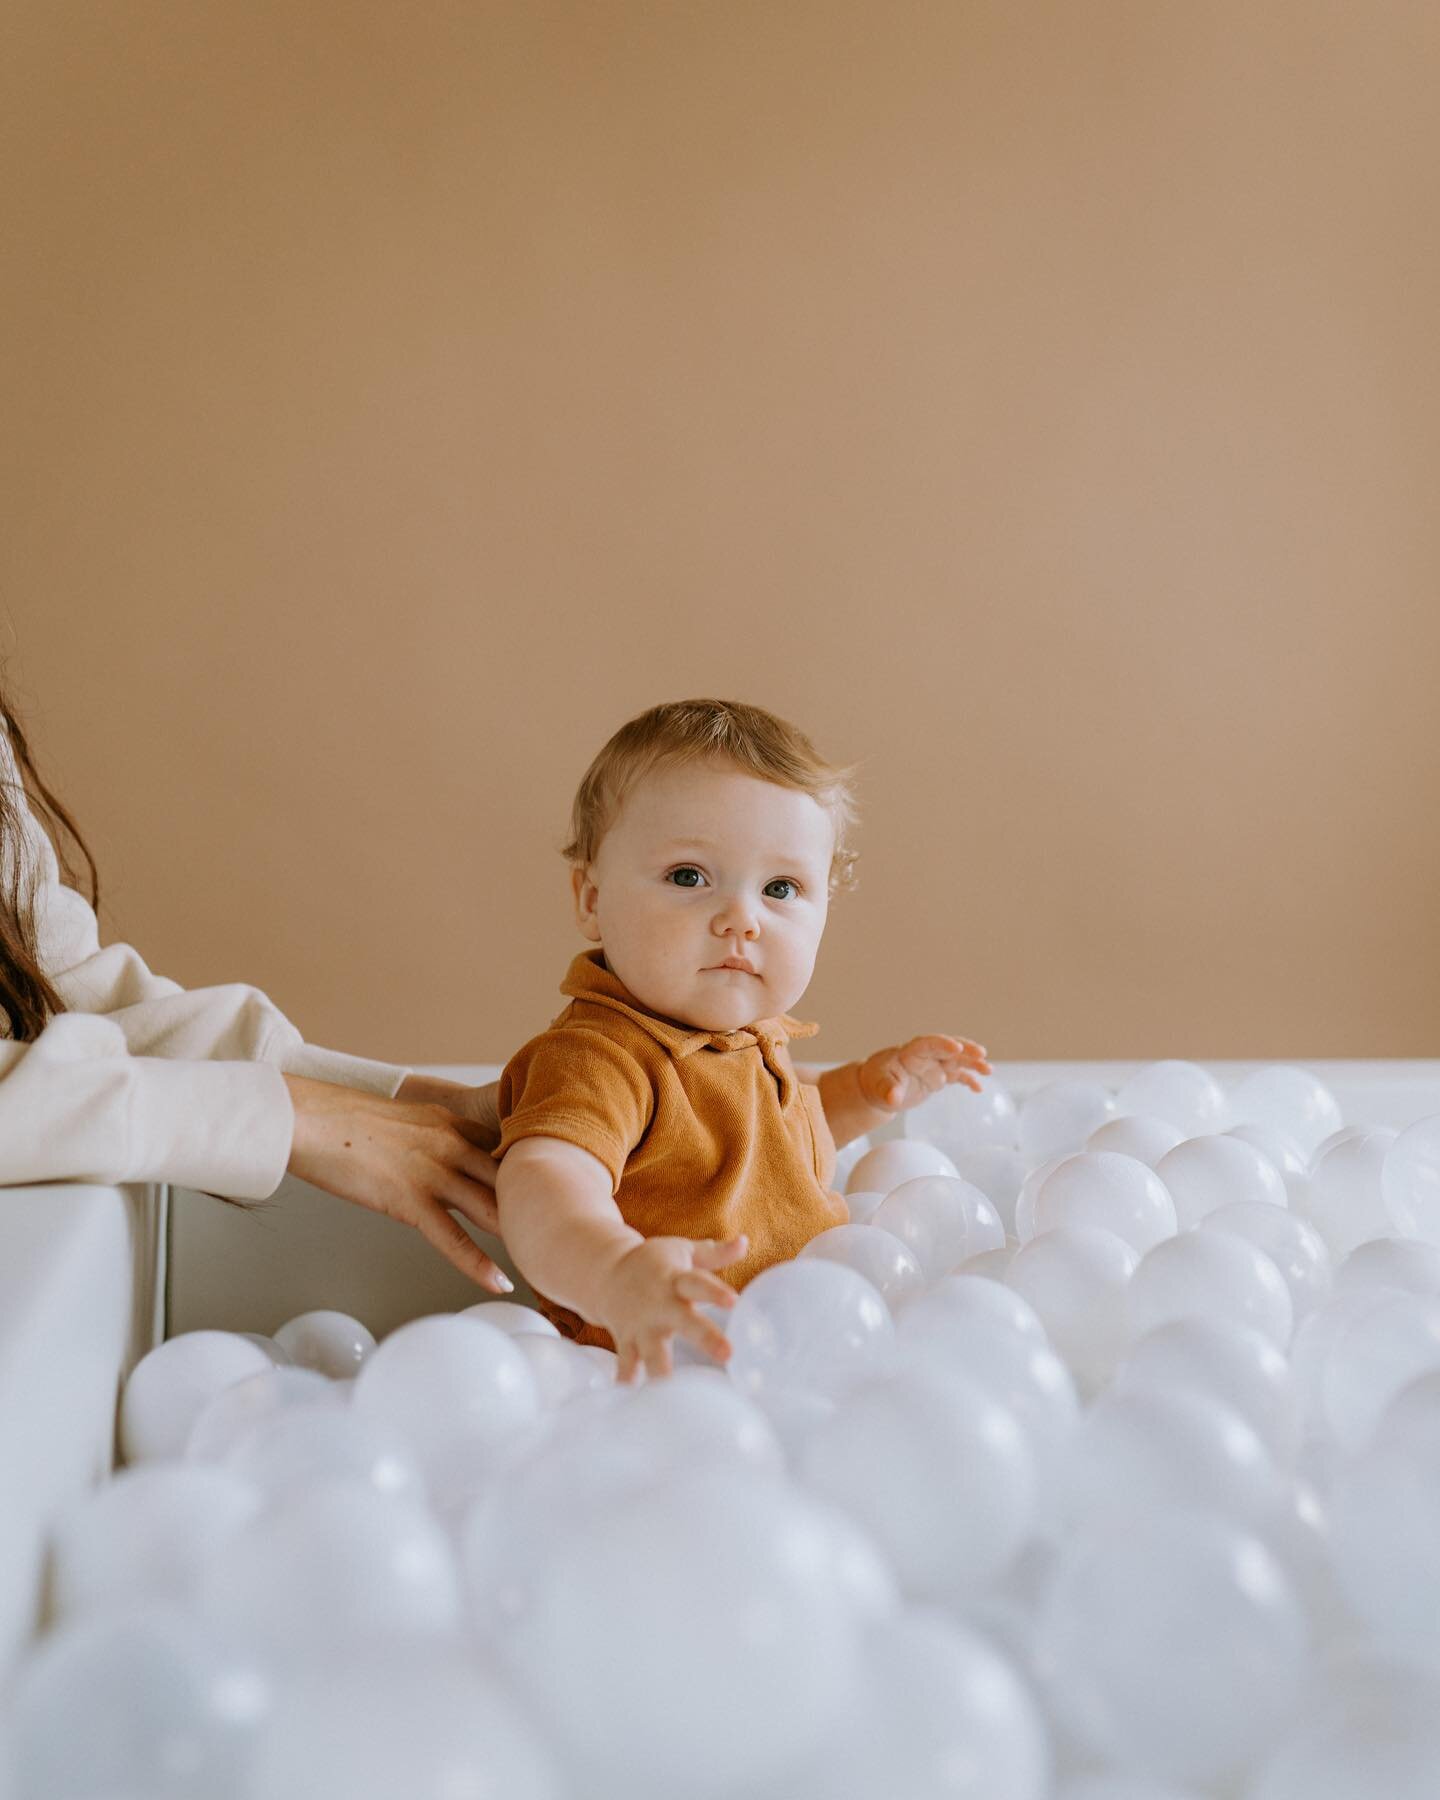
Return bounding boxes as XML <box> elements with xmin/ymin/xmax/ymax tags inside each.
<box><xmin>596</xmin><ymin>1237</ymin><xmax>745</xmax><ymax>1381</ymax></box>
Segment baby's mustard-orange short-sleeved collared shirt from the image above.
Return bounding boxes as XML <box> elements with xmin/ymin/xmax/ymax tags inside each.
<box><xmin>495</xmin><ymin>950</ymin><xmax>850</xmax><ymax>1345</ymax></box>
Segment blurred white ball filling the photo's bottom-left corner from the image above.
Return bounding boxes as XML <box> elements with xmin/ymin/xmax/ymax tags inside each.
<box><xmin>11</xmin><ymin>1609</ymin><xmax>270</xmax><ymax>1800</ymax></box>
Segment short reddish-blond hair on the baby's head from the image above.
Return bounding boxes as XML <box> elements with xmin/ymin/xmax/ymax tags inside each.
<box><xmin>562</xmin><ymin>700</ymin><xmax>859</xmax><ymax>895</ymax></box>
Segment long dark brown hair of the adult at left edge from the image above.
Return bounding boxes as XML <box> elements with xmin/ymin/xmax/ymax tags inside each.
<box><xmin>0</xmin><ymin>688</ymin><xmax>101</xmax><ymax>1044</ymax></box>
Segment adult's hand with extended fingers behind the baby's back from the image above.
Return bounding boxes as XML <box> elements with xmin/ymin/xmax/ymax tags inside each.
<box><xmin>284</xmin><ymin>1075</ymin><xmax>513</xmax><ymax>1294</ymax></box>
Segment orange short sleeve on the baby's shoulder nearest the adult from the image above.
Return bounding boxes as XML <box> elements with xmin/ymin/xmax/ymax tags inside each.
<box><xmin>495</xmin><ymin>1026</ymin><xmax>655</xmax><ymax>1192</ymax></box>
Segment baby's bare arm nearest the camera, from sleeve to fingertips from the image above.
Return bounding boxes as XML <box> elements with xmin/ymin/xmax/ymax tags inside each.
<box><xmin>495</xmin><ymin>1136</ymin><xmax>745</xmax><ymax>1381</ymax></box>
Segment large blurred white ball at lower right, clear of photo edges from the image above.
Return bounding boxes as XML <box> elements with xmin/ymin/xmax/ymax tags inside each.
<box><xmin>1040</xmin><ymin>1510</ymin><xmax>1307</xmax><ymax>1782</ymax></box>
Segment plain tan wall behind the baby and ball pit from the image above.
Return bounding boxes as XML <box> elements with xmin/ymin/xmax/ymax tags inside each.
<box><xmin>0</xmin><ymin>0</ymin><xmax>1440</xmax><ymax>1060</ymax></box>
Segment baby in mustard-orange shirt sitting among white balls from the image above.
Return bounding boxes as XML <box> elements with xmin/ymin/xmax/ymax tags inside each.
<box><xmin>495</xmin><ymin>700</ymin><xmax>990</xmax><ymax>1381</ymax></box>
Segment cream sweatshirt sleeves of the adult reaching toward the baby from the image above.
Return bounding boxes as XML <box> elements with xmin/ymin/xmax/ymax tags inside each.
<box><xmin>0</xmin><ymin>731</ymin><xmax>407</xmax><ymax>1199</ymax></box>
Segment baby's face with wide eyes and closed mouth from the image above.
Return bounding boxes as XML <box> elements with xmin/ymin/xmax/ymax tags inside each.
<box><xmin>574</xmin><ymin>761</ymin><xmax>835</xmax><ymax>1031</ymax></box>
